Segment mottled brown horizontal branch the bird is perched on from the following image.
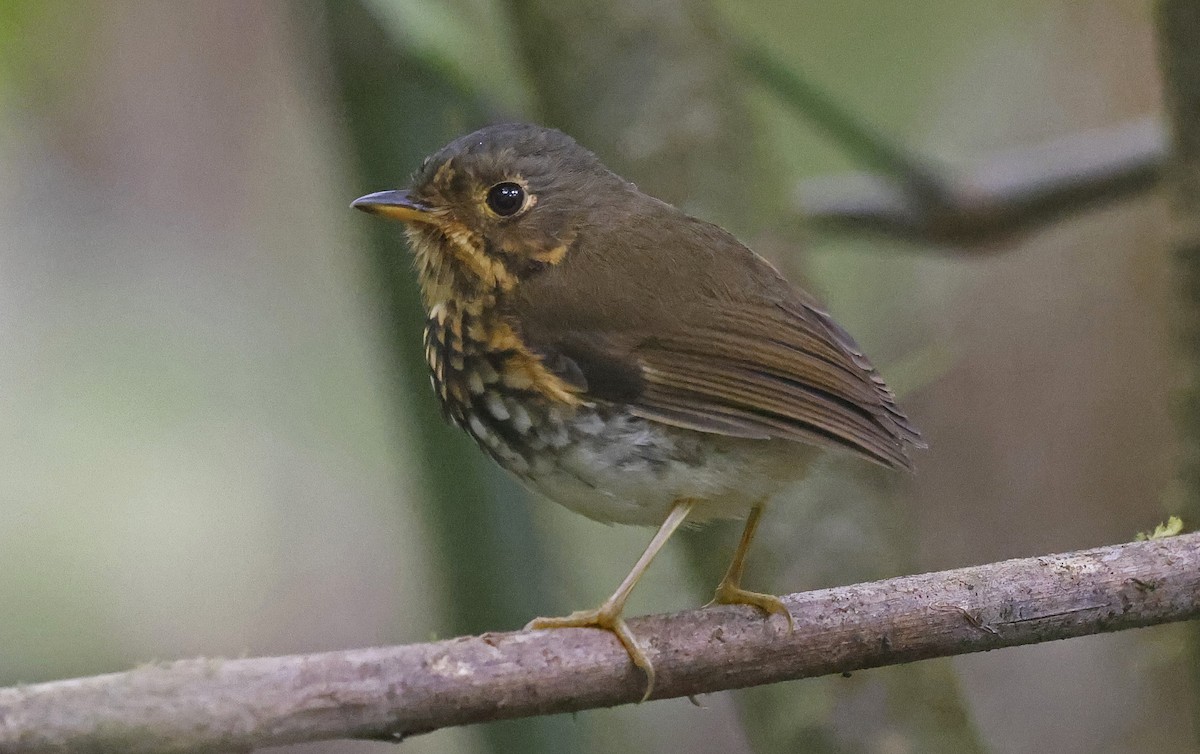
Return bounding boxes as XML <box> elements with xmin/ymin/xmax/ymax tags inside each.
<box><xmin>0</xmin><ymin>533</ymin><xmax>1200</xmax><ymax>754</ymax></box>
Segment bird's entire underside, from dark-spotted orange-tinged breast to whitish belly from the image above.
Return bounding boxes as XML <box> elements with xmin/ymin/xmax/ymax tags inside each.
<box><xmin>426</xmin><ymin>306</ymin><xmax>817</xmax><ymax>526</ymax></box>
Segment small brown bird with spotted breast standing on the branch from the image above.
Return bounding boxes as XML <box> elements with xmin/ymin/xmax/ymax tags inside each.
<box><xmin>353</xmin><ymin>124</ymin><xmax>924</xmax><ymax>698</ymax></box>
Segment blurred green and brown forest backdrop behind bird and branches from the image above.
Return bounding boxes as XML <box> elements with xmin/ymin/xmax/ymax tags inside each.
<box><xmin>0</xmin><ymin>0</ymin><xmax>1200</xmax><ymax>754</ymax></box>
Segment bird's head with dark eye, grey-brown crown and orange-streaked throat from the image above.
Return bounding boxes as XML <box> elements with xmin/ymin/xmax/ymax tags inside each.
<box><xmin>353</xmin><ymin>124</ymin><xmax>630</xmax><ymax>305</ymax></box>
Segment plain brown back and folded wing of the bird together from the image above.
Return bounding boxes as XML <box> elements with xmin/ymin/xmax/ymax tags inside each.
<box><xmin>510</xmin><ymin>204</ymin><xmax>923</xmax><ymax>468</ymax></box>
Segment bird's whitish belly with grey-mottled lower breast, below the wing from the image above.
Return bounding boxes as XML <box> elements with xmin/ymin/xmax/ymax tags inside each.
<box><xmin>446</xmin><ymin>374</ymin><xmax>816</xmax><ymax>526</ymax></box>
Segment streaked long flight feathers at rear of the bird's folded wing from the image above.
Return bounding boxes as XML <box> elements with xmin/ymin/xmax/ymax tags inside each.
<box><xmin>634</xmin><ymin>298</ymin><xmax>919</xmax><ymax>468</ymax></box>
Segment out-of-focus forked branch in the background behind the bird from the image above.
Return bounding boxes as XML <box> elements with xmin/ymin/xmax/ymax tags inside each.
<box><xmin>731</xmin><ymin>40</ymin><xmax>1165</xmax><ymax>251</ymax></box>
